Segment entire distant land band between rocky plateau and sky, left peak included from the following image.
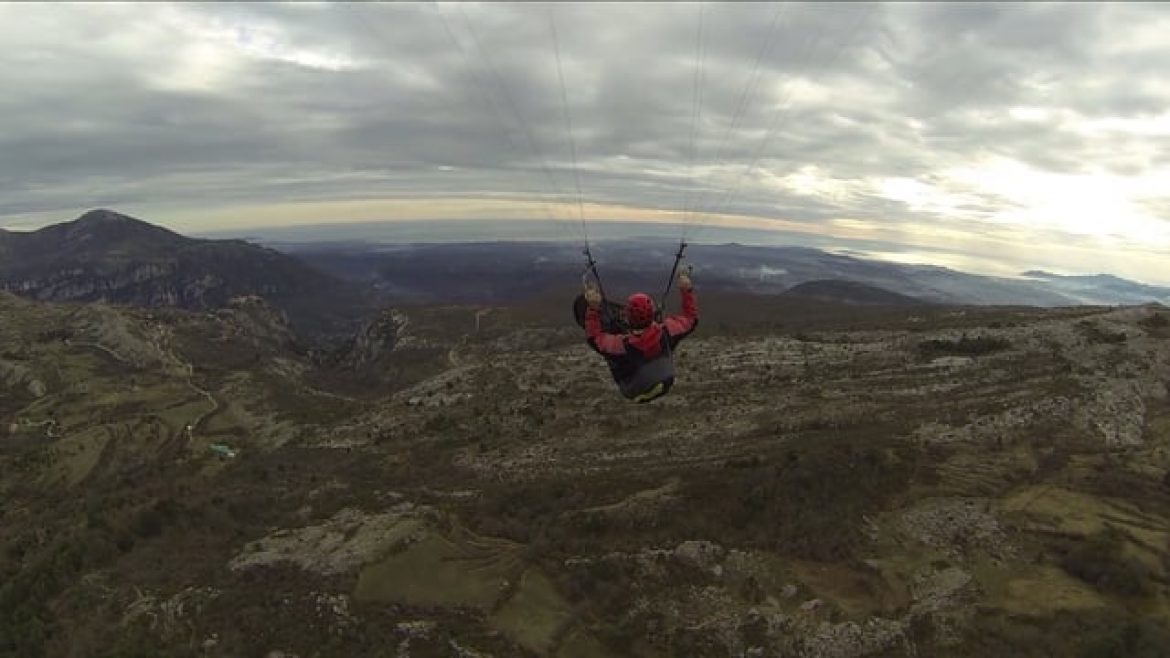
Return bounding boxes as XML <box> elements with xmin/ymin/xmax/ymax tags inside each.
<box><xmin>0</xmin><ymin>210</ymin><xmax>1170</xmax><ymax>336</ymax></box>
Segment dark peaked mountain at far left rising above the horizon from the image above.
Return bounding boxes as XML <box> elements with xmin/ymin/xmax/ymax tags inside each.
<box><xmin>0</xmin><ymin>210</ymin><xmax>369</xmax><ymax>334</ymax></box>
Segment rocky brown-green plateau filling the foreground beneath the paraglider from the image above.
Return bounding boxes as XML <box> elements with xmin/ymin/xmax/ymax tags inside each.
<box><xmin>0</xmin><ymin>290</ymin><xmax>1170</xmax><ymax>658</ymax></box>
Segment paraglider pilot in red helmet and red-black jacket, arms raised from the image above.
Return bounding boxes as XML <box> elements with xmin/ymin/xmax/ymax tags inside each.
<box><xmin>584</xmin><ymin>272</ymin><xmax>698</xmax><ymax>403</ymax></box>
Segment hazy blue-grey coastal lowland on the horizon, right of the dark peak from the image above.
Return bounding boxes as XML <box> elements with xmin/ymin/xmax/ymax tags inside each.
<box><xmin>278</xmin><ymin>239</ymin><xmax>1170</xmax><ymax>307</ymax></box>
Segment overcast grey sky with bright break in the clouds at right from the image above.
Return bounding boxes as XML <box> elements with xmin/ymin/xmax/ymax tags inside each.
<box><xmin>0</xmin><ymin>2</ymin><xmax>1170</xmax><ymax>283</ymax></box>
